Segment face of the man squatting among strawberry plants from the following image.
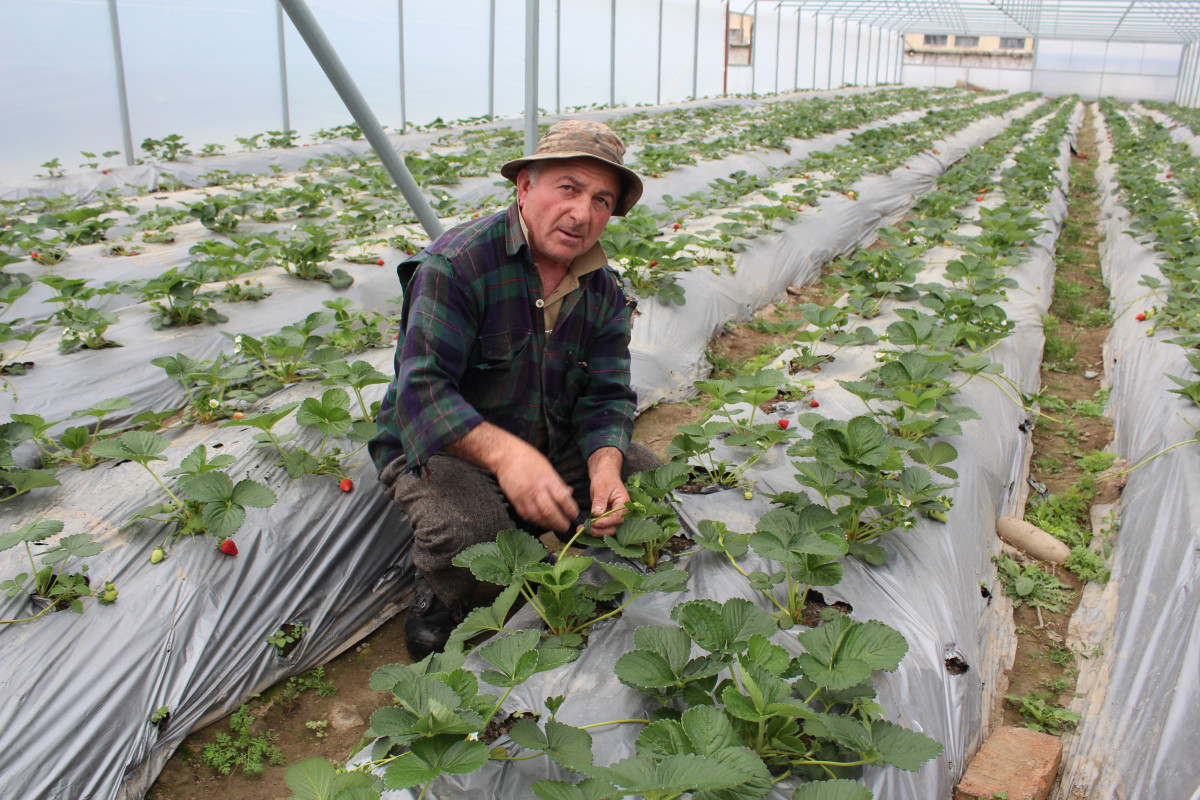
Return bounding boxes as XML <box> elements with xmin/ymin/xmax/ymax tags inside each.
<box><xmin>517</xmin><ymin>158</ymin><xmax>620</xmax><ymax>266</ymax></box>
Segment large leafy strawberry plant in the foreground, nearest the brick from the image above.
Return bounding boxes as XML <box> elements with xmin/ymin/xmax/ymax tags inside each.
<box><xmin>609</xmin><ymin>599</ymin><xmax>942</xmax><ymax>796</ymax></box>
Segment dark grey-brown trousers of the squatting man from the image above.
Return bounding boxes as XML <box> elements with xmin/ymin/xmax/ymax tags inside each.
<box><xmin>379</xmin><ymin>441</ymin><xmax>662</xmax><ymax>608</ymax></box>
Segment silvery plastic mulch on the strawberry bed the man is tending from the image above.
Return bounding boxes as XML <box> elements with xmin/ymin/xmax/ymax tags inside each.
<box><xmin>350</xmin><ymin>104</ymin><xmax>1080</xmax><ymax>800</ymax></box>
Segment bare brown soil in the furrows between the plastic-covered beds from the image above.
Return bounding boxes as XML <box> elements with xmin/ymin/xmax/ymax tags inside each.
<box><xmin>146</xmin><ymin>110</ymin><xmax>1118</xmax><ymax>800</ymax></box>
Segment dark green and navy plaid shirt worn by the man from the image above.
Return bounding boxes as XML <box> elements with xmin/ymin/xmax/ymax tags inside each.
<box><xmin>368</xmin><ymin>203</ymin><xmax>636</xmax><ymax>473</ymax></box>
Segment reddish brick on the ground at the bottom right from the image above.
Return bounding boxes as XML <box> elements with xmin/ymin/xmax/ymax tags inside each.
<box><xmin>954</xmin><ymin>728</ymin><xmax>1062</xmax><ymax>800</ymax></box>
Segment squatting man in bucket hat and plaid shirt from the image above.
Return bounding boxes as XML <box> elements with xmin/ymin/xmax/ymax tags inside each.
<box><xmin>371</xmin><ymin>120</ymin><xmax>659</xmax><ymax>660</ymax></box>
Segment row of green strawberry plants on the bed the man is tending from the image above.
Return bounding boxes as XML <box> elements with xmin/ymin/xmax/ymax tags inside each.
<box><xmin>300</xmin><ymin>98</ymin><xmax>1069</xmax><ymax>798</ymax></box>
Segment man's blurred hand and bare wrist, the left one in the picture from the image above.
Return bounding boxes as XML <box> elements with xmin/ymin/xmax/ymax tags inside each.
<box><xmin>446</xmin><ymin>422</ymin><xmax>580</xmax><ymax>533</ymax></box>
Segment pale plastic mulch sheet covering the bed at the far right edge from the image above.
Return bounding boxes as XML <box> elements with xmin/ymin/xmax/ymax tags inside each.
<box><xmin>1058</xmin><ymin>107</ymin><xmax>1200</xmax><ymax>800</ymax></box>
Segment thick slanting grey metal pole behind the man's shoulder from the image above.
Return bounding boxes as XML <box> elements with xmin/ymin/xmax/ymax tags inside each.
<box><xmin>280</xmin><ymin>0</ymin><xmax>442</xmax><ymax>239</ymax></box>
